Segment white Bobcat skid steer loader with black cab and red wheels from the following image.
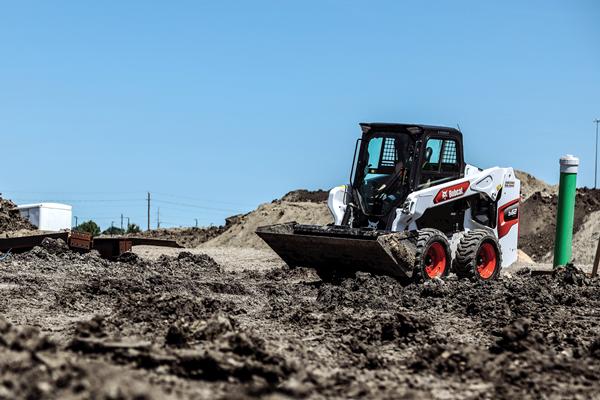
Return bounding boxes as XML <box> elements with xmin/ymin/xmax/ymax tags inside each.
<box><xmin>256</xmin><ymin>123</ymin><xmax>520</xmax><ymax>280</ymax></box>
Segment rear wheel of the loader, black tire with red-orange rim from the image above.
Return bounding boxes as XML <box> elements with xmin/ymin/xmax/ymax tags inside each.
<box><xmin>453</xmin><ymin>229</ymin><xmax>502</xmax><ymax>281</ymax></box>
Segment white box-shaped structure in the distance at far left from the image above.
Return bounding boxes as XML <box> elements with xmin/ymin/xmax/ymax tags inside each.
<box><xmin>17</xmin><ymin>203</ymin><xmax>73</xmax><ymax>231</ymax></box>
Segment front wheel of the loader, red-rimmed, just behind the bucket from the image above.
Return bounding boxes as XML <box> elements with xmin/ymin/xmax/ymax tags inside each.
<box><xmin>413</xmin><ymin>228</ymin><xmax>452</xmax><ymax>281</ymax></box>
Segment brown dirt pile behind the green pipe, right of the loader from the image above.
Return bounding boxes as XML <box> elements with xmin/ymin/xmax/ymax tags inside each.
<box><xmin>519</xmin><ymin>188</ymin><xmax>600</xmax><ymax>264</ymax></box>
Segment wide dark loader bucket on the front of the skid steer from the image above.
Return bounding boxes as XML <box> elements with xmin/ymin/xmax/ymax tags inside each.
<box><xmin>256</xmin><ymin>222</ymin><xmax>416</xmax><ymax>278</ymax></box>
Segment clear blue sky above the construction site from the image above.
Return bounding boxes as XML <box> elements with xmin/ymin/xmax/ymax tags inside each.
<box><xmin>0</xmin><ymin>0</ymin><xmax>600</xmax><ymax>227</ymax></box>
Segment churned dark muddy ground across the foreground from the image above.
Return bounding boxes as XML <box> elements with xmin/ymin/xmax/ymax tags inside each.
<box><xmin>0</xmin><ymin>241</ymin><xmax>600</xmax><ymax>399</ymax></box>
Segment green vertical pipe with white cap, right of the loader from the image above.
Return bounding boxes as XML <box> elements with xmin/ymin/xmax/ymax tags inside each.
<box><xmin>554</xmin><ymin>154</ymin><xmax>579</xmax><ymax>268</ymax></box>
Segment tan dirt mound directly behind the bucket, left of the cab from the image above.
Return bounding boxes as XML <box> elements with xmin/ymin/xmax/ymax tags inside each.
<box><xmin>206</xmin><ymin>201</ymin><xmax>333</xmax><ymax>249</ymax></box>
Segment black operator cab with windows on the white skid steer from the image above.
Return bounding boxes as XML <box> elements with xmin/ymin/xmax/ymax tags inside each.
<box><xmin>349</xmin><ymin>123</ymin><xmax>465</xmax><ymax>229</ymax></box>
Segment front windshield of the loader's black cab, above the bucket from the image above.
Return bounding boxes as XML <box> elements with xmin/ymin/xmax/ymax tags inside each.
<box><xmin>355</xmin><ymin>133</ymin><xmax>413</xmax><ymax>215</ymax></box>
